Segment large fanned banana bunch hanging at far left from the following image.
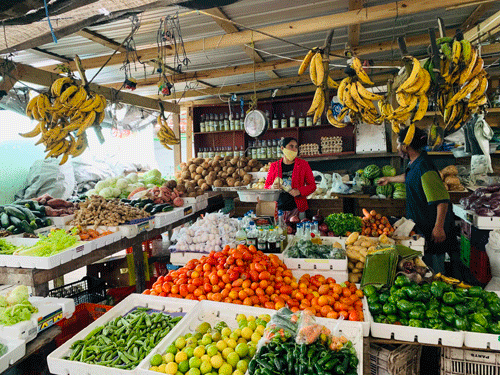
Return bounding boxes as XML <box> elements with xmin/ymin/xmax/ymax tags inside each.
<box><xmin>21</xmin><ymin>77</ymin><xmax>106</xmax><ymax>165</ymax></box>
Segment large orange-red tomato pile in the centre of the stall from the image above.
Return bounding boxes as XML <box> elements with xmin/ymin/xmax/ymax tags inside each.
<box><xmin>144</xmin><ymin>245</ymin><xmax>363</xmax><ymax>321</ymax></box>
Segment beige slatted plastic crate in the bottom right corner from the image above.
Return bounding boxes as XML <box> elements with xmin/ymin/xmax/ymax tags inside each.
<box><xmin>441</xmin><ymin>348</ymin><xmax>500</xmax><ymax>375</ymax></box>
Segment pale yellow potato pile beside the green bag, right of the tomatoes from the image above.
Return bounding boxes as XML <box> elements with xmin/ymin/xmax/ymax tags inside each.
<box><xmin>345</xmin><ymin>232</ymin><xmax>394</xmax><ymax>283</ymax></box>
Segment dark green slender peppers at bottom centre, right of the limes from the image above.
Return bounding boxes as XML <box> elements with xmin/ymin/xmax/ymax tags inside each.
<box><xmin>248</xmin><ymin>338</ymin><xmax>358</xmax><ymax>375</ymax></box>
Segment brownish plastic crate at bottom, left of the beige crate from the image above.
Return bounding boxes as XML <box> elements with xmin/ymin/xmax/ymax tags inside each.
<box><xmin>370</xmin><ymin>344</ymin><xmax>422</xmax><ymax>375</ymax></box>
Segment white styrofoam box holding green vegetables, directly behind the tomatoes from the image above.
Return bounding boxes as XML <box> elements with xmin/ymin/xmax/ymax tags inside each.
<box><xmin>283</xmin><ymin>237</ymin><xmax>347</xmax><ymax>272</ymax></box>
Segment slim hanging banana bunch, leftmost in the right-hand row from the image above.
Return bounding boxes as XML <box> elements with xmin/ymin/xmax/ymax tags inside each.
<box><xmin>298</xmin><ymin>48</ymin><xmax>345</xmax><ymax>127</ymax></box>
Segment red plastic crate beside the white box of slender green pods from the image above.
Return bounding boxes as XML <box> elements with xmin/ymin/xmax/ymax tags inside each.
<box><xmin>55</xmin><ymin>303</ymin><xmax>113</xmax><ymax>346</ymax></box>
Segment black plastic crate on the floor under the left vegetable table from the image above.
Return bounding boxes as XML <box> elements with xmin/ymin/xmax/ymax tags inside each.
<box><xmin>49</xmin><ymin>276</ymin><xmax>106</xmax><ymax>305</ymax></box>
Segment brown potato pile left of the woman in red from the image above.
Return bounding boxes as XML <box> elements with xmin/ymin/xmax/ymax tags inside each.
<box><xmin>176</xmin><ymin>156</ymin><xmax>262</xmax><ymax>197</ymax></box>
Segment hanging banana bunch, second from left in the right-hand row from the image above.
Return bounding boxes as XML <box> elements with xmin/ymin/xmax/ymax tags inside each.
<box><xmin>334</xmin><ymin>57</ymin><xmax>385</xmax><ymax>127</ymax></box>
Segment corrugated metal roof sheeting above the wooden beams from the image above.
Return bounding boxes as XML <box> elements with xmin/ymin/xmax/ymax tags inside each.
<box><xmin>5</xmin><ymin>0</ymin><xmax>500</xmax><ymax>102</ymax></box>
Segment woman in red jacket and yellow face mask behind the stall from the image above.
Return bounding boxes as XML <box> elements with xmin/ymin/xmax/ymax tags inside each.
<box><xmin>266</xmin><ymin>137</ymin><xmax>316</xmax><ymax>219</ymax></box>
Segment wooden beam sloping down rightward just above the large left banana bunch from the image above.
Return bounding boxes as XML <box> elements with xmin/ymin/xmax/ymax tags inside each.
<box><xmin>0</xmin><ymin>59</ymin><xmax>180</xmax><ymax>113</ymax></box>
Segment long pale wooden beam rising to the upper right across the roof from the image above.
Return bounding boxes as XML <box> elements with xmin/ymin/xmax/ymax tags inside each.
<box><xmin>40</xmin><ymin>0</ymin><xmax>491</xmax><ymax>70</ymax></box>
